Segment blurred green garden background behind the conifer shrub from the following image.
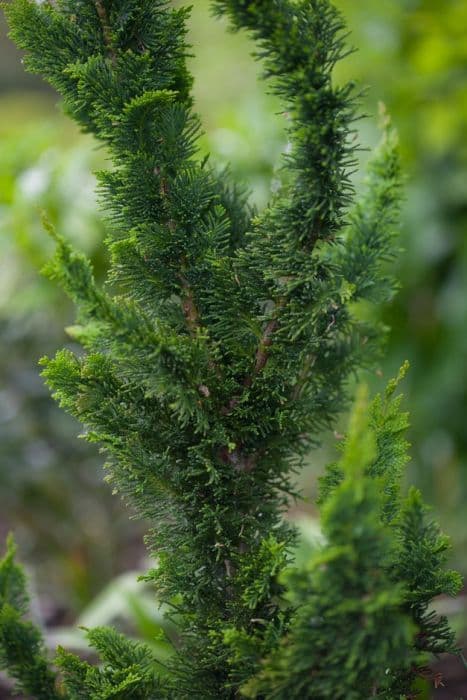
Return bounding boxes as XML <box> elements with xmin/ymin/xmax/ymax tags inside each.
<box><xmin>0</xmin><ymin>0</ymin><xmax>467</xmax><ymax>698</ymax></box>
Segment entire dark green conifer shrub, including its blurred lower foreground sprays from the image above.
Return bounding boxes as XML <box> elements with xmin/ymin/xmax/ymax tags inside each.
<box><xmin>0</xmin><ymin>0</ymin><xmax>459</xmax><ymax>700</ymax></box>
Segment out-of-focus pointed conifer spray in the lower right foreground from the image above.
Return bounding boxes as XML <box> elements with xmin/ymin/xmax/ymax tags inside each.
<box><xmin>243</xmin><ymin>371</ymin><xmax>462</xmax><ymax>700</ymax></box>
